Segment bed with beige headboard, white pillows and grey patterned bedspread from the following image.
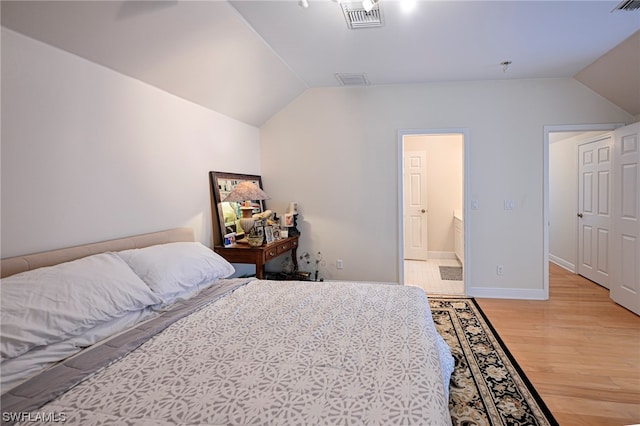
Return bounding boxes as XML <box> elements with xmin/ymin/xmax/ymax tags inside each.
<box><xmin>0</xmin><ymin>228</ymin><xmax>453</xmax><ymax>425</ymax></box>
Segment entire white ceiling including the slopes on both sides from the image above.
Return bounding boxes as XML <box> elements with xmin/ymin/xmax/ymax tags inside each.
<box><xmin>1</xmin><ymin>0</ymin><xmax>640</xmax><ymax>126</ymax></box>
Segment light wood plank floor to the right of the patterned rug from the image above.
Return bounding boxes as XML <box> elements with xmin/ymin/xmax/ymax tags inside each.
<box><xmin>477</xmin><ymin>264</ymin><xmax>640</xmax><ymax>426</ymax></box>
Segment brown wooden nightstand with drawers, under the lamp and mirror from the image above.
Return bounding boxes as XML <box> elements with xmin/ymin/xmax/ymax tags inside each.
<box><xmin>213</xmin><ymin>235</ymin><xmax>300</xmax><ymax>279</ymax></box>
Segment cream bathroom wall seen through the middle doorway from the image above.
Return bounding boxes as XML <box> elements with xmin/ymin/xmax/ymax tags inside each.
<box><xmin>404</xmin><ymin>134</ymin><xmax>463</xmax><ymax>258</ymax></box>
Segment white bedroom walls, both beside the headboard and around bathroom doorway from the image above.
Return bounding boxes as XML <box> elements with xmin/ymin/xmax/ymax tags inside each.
<box><xmin>1</xmin><ymin>25</ymin><xmax>633</xmax><ymax>295</ymax></box>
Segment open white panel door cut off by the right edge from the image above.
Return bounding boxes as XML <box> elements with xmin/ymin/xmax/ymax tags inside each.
<box><xmin>611</xmin><ymin>123</ymin><xmax>640</xmax><ymax>315</ymax></box>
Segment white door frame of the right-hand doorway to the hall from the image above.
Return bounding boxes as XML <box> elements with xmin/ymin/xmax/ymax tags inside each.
<box><xmin>542</xmin><ymin>123</ymin><xmax>624</xmax><ymax>300</ymax></box>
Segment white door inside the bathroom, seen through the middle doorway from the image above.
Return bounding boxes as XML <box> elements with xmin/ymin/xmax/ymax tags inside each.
<box><xmin>403</xmin><ymin>151</ymin><xmax>428</xmax><ymax>260</ymax></box>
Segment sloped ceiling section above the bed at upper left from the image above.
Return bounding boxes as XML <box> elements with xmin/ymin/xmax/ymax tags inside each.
<box><xmin>2</xmin><ymin>1</ymin><xmax>306</xmax><ymax>126</ymax></box>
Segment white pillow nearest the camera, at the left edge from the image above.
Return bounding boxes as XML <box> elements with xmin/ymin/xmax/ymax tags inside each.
<box><xmin>0</xmin><ymin>253</ymin><xmax>161</xmax><ymax>360</ymax></box>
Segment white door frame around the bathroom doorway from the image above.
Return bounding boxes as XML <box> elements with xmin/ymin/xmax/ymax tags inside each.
<box><xmin>397</xmin><ymin>128</ymin><xmax>471</xmax><ymax>295</ymax></box>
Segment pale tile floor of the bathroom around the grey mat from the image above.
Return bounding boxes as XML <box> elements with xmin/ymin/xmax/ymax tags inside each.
<box><xmin>404</xmin><ymin>259</ymin><xmax>465</xmax><ymax>296</ymax></box>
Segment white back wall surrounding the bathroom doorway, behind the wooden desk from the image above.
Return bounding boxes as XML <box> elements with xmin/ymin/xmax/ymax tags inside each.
<box><xmin>261</xmin><ymin>79</ymin><xmax>632</xmax><ymax>297</ymax></box>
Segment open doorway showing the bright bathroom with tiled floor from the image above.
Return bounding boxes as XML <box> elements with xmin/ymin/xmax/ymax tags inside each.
<box><xmin>399</xmin><ymin>130</ymin><xmax>465</xmax><ymax>295</ymax></box>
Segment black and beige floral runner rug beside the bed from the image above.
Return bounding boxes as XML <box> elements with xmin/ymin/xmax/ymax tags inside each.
<box><xmin>429</xmin><ymin>297</ymin><xmax>558</xmax><ymax>426</ymax></box>
